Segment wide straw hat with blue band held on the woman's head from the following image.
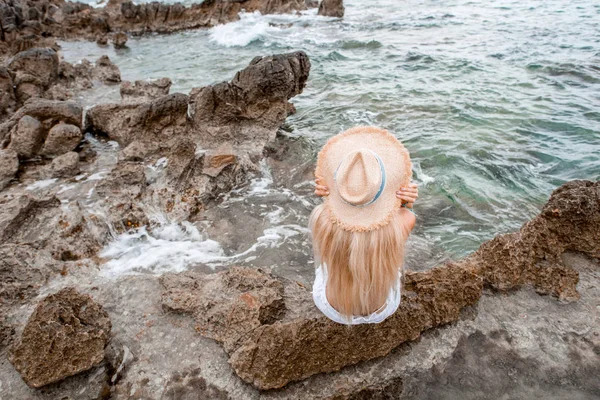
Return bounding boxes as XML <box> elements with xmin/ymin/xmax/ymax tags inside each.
<box><xmin>315</xmin><ymin>126</ymin><xmax>412</xmax><ymax>232</ymax></box>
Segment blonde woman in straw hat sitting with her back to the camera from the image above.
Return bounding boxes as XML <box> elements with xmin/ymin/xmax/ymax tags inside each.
<box><xmin>310</xmin><ymin>127</ymin><xmax>418</xmax><ymax>325</ymax></box>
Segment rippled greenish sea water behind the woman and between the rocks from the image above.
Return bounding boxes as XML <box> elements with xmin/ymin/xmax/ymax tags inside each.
<box><xmin>57</xmin><ymin>0</ymin><xmax>600</xmax><ymax>276</ymax></box>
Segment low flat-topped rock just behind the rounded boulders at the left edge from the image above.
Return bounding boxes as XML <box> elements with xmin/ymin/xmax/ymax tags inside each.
<box><xmin>0</xmin><ymin>99</ymin><xmax>83</xmax><ymax>144</ymax></box>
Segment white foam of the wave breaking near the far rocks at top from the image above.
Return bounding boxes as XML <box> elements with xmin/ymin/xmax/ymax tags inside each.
<box><xmin>210</xmin><ymin>11</ymin><xmax>269</xmax><ymax>47</ymax></box>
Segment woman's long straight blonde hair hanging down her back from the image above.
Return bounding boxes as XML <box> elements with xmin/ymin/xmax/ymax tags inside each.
<box><xmin>309</xmin><ymin>204</ymin><xmax>410</xmax><ymax>318</ymax></box>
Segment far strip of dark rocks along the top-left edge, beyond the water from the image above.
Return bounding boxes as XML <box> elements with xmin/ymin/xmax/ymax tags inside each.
<box><xmin>0</xmin><ymin>0</ymin><xmax>315</xmax><ymax>57</ymax></box>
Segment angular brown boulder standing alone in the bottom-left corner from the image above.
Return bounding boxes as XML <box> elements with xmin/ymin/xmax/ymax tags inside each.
<box><xmin>9</xmin><ymin>288</ymin><xmax>111</xmax><ymax>388</ymax></box>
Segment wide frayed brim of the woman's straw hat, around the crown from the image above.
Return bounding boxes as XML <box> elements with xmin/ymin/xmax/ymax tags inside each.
<box><xmin>315</xmin><ymin>126</ymin><xmax>412</xmax><ymax>232</ymax></box>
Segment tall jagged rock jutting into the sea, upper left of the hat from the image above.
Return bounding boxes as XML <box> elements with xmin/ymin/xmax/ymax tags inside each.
<box><xmin>190</xmin><ymin>52</ymin><xmax>310</xmax><ymax>153</ymax></box>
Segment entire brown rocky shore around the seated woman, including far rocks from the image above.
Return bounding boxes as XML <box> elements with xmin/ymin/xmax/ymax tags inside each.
<box><xmin>0</xmin><ymin>0</ymin><xmax>600</xmax><ymax>399</ymax></box>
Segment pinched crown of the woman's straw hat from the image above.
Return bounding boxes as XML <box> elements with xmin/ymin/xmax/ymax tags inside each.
<box><xmin>335</xmin><ymin>149</ymin><xmax>384</xmax><ymax>206</ymax></box>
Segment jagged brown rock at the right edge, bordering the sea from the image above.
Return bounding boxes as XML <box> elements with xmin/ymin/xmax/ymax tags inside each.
<box><xmin>468</xmin><ymin>181</ymin><xmax>600</xmax><ymax>300</ymax></box>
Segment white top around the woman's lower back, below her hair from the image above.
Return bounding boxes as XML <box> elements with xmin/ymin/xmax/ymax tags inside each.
<box><xmin>313</xmin><ymin>264</ymin><xmax>402</xmax><ymax>325</ymax></box>
